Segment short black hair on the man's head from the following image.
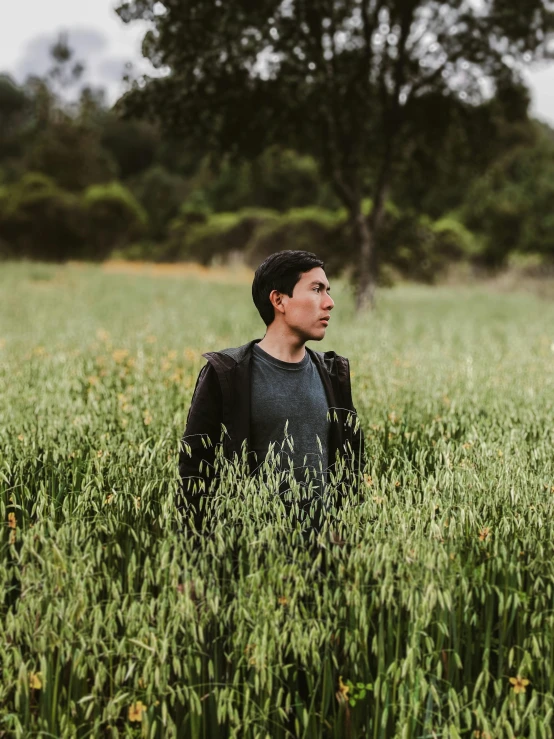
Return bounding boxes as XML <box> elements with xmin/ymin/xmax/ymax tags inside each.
<box><xmin>252</xmin><ymin>249</ymin><xmax>325</xmax><ymax>326</ymax></box>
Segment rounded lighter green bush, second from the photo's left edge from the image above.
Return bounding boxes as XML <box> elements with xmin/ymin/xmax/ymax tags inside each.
<box><xmin>83</xmin><ymin>182</ymin><xmax>148</xmax><ymax>259</ymax></box>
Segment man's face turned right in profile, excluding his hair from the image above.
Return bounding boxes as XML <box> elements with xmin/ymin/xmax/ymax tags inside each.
<box><xmin>282</xmin><ymin>267</ymin><xmax>335</xmax><ymax>341</ymax></box>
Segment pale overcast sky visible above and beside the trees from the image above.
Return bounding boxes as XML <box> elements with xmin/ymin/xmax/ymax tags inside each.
<box><xmin>0</xmin><ymin>0</ymin><xmax>554</xmax><ymax>125</ymax></box>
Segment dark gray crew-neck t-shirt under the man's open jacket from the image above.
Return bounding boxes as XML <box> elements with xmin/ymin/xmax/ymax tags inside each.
<box><xmin>250</xmin><ymin>344</ymin><xmax>329</xmax><ymax>484</ymax></box>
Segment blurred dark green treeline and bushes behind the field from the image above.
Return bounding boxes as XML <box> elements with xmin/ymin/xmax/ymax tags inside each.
<box><xmin>0</xmin><ymin>61</ymin><xmax>554</xmax><ymax>280</ymax></box>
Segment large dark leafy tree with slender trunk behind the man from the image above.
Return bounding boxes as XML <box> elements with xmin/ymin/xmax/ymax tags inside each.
<box><xmin>118</xmin><ymin>0</ymin><xmax>554</xmax><ymax>307</ymax></box>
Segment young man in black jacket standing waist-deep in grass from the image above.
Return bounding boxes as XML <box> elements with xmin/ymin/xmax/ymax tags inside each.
<box><xmin>179</xmin><ymin>251</ymin><xmax>363</xmax><ymax>530</ymax></box>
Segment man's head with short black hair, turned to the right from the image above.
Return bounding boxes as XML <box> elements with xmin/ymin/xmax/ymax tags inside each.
<box><xmin>252</xmin><ymin>251</ymin><xmax>334</xmax><ymax>341</ymax></box>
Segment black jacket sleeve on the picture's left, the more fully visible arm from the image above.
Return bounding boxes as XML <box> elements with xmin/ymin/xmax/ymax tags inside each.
<box><xmin>177</xmin><ymin>363</ymin><xmax>223</xmax><ymax>531</ymax></box>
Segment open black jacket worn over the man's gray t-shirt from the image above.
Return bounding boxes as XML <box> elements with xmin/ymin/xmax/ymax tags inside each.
<box><xmin>178</xmin><ymin>339</ymin><xmax>365</xmax><ymax>525</ymax></box>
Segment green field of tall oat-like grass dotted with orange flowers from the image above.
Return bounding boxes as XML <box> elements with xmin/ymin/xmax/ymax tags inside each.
<box><xmin>0</xmin><ymin>264</ymin><xmax>554</xmax><ymax>739</ymax></box>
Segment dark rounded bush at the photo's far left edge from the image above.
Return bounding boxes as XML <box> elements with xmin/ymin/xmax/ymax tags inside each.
<box><xmin>0</xmin><ymin>172</ymin><xmax>86</xmax><ymax>261</ymax></box>
